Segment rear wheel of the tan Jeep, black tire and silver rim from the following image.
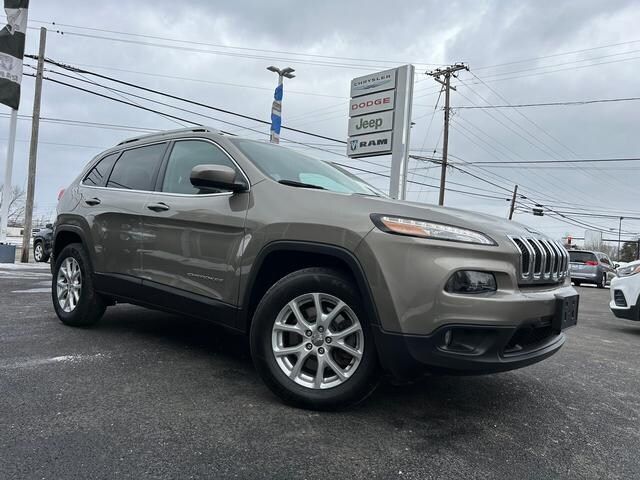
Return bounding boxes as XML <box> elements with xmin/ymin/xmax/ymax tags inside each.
<box><xmin>51</xmin><ymin>243</ymin><xmax>106</xmax><ymax>327</ymax></box>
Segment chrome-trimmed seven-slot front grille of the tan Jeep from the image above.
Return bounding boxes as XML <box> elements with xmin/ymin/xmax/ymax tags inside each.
<box><xmin>509</xmin><ymin>237</ymin><xmax>569</xmax><ymax>284</ymax></box>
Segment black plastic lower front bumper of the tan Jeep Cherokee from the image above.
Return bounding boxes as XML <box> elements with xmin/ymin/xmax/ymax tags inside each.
<box><xmin>374</xmin><ymin>325</ymin><xmax>565</xmax><ymax>380</ymax></box>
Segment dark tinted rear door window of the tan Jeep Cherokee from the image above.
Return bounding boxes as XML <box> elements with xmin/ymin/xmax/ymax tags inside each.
<box><xmin>107</xmin><ymin>143</ymin><xmax>167</xmax><ymax>191</ymax></box>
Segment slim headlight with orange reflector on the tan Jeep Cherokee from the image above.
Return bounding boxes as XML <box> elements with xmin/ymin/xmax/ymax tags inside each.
<box><xmin>371</xmin><ymin>214</ymin><xmax>497</xmax><ymax>245</ymax></box>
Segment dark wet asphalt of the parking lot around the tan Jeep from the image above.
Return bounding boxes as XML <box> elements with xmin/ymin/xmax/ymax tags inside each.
<box><xmin>0</xmin><ymin>265</ymin><xmax>640</xmax><ymax>479</ymax></box>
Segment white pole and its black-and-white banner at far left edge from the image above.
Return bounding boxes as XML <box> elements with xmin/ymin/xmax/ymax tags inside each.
<box><xmin>0</xmin><ymin>0</ymin><xmax>29</xmax><ymax>243</ymax></box>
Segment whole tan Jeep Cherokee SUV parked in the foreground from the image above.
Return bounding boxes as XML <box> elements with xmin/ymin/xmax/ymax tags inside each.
<box><xmin>52</xmin><ymin>128</ymin><xmax>578</xmax><ymax>409</ymax></box>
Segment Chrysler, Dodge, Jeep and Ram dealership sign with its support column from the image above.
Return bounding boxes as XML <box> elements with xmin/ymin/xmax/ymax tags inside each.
<box><xmin>347</xmin><ymin>65</ymin><xmax>415</xmax><ymax>200</ymax></box>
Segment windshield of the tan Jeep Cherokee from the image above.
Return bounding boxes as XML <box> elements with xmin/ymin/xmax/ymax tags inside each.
<box><xmin>229</xmin><ymin>138</ymin><xmax>380</xmax><ymax>196</ymax></box>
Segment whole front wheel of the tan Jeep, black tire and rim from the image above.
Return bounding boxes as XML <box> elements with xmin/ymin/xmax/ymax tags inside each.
<box><xmin>250</xmin><ymin>268</ymin><xmax>380</xmax><ymax>410</ymax></box>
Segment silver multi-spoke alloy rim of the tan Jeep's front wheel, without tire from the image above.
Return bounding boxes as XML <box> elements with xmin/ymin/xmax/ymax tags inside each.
<box><xmin>271</xmin><ymin>293</ymin><xmax>364</xmax><ymax>389</ymax></box>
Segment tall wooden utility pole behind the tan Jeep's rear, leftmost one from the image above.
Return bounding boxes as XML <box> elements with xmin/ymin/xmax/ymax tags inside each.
<box><xmin>20</xmin><ymin>27</ymin><xmax>47</xmax><ymax>263</ymax></box>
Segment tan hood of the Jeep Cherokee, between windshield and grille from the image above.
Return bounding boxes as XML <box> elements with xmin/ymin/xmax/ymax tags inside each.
<box><xmin>354</xmin><ymin>196</ymin><xmax>546</xmax><ymax>240</ymax></box>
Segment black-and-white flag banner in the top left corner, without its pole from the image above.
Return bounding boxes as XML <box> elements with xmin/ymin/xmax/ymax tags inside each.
<box><xmin>0</xmin><ymin>0</ymin><xmax>29</xmax><ymax>110</ymax></box>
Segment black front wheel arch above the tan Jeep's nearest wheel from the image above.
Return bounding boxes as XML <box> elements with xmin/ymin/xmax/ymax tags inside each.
<box><xmin>238</xmin><ymin>241</ymin><xmax>380</xmax><ymax>332</ymax></box>
